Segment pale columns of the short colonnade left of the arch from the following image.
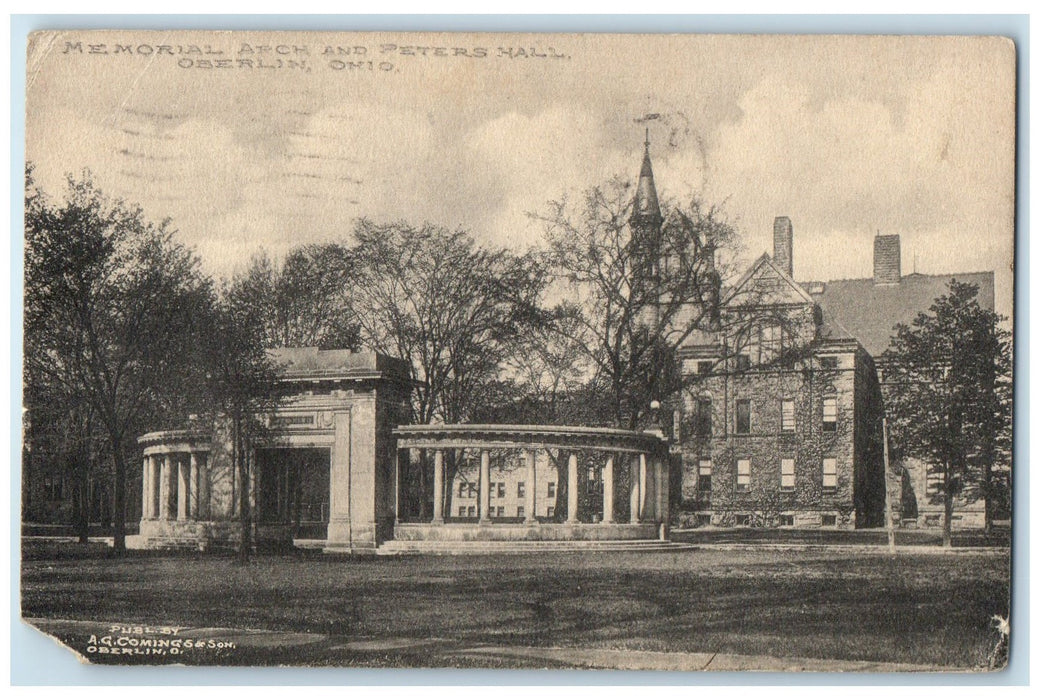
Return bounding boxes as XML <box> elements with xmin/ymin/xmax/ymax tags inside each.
<box><xmin>141</xmin><ymin>451</ymin><xmax>209</xmax><ymax>520</ymax></box>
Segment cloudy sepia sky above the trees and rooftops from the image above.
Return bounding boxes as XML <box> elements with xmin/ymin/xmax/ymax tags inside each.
<box><xmin>26</xmin><ymin>32</ymin><xmax>1015</xmax><ymax>313</ymax></box>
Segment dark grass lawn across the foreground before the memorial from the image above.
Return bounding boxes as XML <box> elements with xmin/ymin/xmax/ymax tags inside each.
<box><xmin>22</xmin><ymin>541</ymin><xmax>1010</xmax><ymax>668</ymax></box>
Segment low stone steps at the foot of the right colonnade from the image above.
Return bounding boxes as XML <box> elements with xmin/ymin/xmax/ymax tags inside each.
<box><xmin>375</xmin><ymin>540</ymin><xmax>695</xmax><ymax>555</ymax></box>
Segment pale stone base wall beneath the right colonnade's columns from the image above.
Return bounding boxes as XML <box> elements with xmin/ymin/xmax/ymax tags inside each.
<box><xmin>394</xmin><ymin>522</ymin><xmax>660</xmax><ymax>542</ymax></box>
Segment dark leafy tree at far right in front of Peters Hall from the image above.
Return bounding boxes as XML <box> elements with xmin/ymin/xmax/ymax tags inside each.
<box><xmin>886</xmin><ymin>280</ymin><xmax>1012</xmax><ymax>546</ymax></box>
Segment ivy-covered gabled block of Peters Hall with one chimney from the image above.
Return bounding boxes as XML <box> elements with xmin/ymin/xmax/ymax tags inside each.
<box><xmin>678</xmin><ymin>237</ymin><xmax>885</xmax><ymax>527</ymax></box>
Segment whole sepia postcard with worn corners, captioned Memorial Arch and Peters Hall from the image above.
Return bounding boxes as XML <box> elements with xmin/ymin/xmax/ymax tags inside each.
<box><xmin>21</xmin><ymin>30</ymin><xmax>1016</xmax><ymax>672</ymax></box>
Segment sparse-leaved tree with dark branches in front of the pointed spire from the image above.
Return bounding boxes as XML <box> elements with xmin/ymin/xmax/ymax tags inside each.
<box><xmin>539</xmin><ymin>179</ymin><xmax>735</xmax><ymax>427</ymax></box>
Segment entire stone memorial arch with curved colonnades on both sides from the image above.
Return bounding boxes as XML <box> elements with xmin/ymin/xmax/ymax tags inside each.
<box><xmin>127</xmin><ymin>348</ymin><xmax>669</xmax><ymax>552</ymax></box>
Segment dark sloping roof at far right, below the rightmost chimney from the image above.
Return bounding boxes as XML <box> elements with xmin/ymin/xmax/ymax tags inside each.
<box><xmin>803</xmin><ymin>273</ymin><xmax>993</xmax><ymax>357</ymax></box>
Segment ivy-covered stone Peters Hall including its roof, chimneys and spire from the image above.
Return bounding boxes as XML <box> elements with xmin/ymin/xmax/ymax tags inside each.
<box><xmin>630</xmin><ymin>141</ymin><xmax>1007</xmax><ymax>527</ymax></box>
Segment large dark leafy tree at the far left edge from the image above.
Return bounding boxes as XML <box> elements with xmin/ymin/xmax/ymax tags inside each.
<box><xmin>25</xmin><ymin>169</ymin><xmax>208</xmax><ymax>553</ymax></box>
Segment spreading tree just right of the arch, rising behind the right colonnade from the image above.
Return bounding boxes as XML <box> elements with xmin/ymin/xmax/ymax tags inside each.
<box><xmin>353</xmin><ymin>219</ymin><xmax>545</xmax><ymax>517</ymax></box>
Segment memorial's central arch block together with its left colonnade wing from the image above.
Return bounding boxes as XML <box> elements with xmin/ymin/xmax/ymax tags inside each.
<box><xmin>127</xmin><ymin>347</ymin><xmax>411</xmax><ymax>551</ymax></box>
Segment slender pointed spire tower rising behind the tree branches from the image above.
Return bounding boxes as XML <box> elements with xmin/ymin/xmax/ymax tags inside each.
<box><xmin>628</xmin><ymin>134</ymin><xmax>665</xmax><ymax>328</ymax></box>
